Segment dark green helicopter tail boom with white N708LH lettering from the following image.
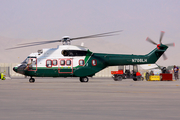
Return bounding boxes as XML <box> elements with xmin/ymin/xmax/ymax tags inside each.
<box><xmin>96</xmin><ymin>45</ymin><xmax>168</xmax><ymax>66</ymax></box>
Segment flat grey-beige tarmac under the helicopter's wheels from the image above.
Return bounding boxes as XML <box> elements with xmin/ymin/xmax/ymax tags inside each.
<box><xmin>0</xmin><ymin>78</ymin><xmax>180</xmax><ymax>120</ymax></box>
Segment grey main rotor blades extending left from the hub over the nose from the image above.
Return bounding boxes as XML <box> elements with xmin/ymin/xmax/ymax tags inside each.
<box><xmin>6</xmin><ymin>41</ymin><xmax>58</xmax><ymax>50</ymax></box>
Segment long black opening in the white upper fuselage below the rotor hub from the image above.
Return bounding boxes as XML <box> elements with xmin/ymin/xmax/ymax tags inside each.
<box><xmin>62</xmin><ymin>50</ymin><xmax>87</xmax><ymax>56</ymax></box>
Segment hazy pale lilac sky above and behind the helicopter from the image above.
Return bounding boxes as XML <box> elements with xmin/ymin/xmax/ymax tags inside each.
<box><xmin>0</xmin><ymin>0</ymin><xmax>180</xmax><ymax>66</ymax></box>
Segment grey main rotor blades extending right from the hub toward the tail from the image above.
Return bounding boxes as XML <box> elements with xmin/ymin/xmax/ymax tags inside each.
<box><xmin>70</xmin><ymin>30</ymin><xmax>122</xmax><ymax>40</ymax></box>
